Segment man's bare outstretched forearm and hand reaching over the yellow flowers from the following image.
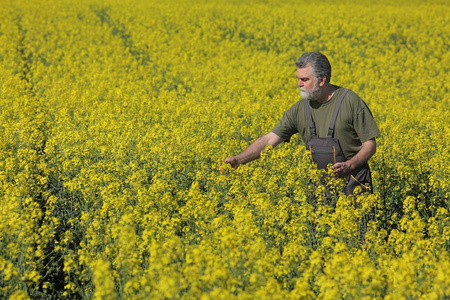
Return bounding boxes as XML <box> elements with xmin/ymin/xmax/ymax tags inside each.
<box><xmin>224</xmin><ymin>132</ymin><xmax>285</xmax><ymax>169</ymax></box>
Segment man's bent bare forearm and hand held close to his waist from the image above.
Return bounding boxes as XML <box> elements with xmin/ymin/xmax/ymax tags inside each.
<box><xmin>333</xmin><ymin>138</ymin><xmax>377</xmax><ymax>178</ymax></box>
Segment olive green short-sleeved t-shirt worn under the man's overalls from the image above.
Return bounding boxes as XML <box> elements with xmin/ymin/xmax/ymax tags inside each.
<box><xmin>272</xmin><ymin>86</ymin><xmax>380</xmax><ymax>159</ymax></box>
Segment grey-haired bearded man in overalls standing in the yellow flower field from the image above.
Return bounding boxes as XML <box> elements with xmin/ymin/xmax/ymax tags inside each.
<box><xmin>224</xmin><ymin>52</ymin><xmax>380</xmax><ymax>195</ymax></box>
